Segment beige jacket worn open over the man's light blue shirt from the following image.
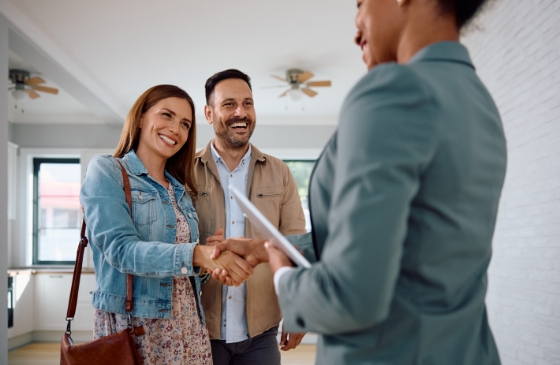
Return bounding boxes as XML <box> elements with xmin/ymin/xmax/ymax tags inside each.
<box><xmin>194</xmin><ymin>142</ymin><xmax>305</xmax><ymax>339</ymax></box>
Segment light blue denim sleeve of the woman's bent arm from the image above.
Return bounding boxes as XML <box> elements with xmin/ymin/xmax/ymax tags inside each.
<box><xmin>80</xmin><ymin>156</ymin><xmax>200</xmax><ymax>277</ymax></box>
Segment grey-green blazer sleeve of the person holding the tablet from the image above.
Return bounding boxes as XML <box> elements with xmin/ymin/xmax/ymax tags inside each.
<box><xmin>278</xmin><ymin>64</ymin><xmax>437</xmax><ymax>334</ymax></box>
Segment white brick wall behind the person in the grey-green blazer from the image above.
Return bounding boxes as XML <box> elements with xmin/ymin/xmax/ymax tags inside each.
<box><xmin>464</xmin><ymin>0</ymin><xmax>560</xmax><ymax>365</ymax></box>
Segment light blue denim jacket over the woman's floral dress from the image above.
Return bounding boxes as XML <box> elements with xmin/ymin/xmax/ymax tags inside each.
<box><xmin>80</xmin><ymin>151</ymin><xmax>205</xmax><ymax>324</ymax></box>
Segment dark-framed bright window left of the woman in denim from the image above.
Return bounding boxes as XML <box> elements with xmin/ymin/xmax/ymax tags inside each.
<box><xmin>33</xmin><ymin>158</ymin><xmax>82</xmax><ymax>265</ymax></box>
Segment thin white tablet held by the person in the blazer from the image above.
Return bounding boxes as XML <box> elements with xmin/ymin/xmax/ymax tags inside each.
<box><xmin>229</xmin><ymin>185</ymin><xmax>311</xmax><ymax>268</ymax></box>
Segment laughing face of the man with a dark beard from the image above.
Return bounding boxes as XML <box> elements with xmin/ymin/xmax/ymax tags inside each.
<box><xmin>204</xmin><ymin>79</ymin><xmax>256</xmax><ymax>150</ymax></box>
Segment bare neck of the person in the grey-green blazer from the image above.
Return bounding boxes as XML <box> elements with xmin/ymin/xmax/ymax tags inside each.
<box><xmin>397</xmin><ymin>2</ymin><xmax>459</xmax><ymax>64</ymax></box>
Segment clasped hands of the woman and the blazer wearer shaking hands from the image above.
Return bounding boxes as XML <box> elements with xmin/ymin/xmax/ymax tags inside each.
<box><xmin>205</xmin><ymin>229</ymin><xmax>268</xmax><ymax>286</ymax></box>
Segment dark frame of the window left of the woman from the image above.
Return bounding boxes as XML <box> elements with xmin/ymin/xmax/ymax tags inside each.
<box><xmin>32</xmin><ymin>157</ymin><xmax>80</xmax><ymax>265</ymax></box>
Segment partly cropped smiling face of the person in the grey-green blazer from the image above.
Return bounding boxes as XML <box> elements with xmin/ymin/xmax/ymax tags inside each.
<box><xmin>355</xmin><ymin>0</ymin><xmax>404</xmax><ymax>70</ymax></box>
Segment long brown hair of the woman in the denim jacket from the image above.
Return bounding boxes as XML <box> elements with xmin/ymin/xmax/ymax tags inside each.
<box><xmin>113</xmin><ymin>85</ymin><xmax>198</xmax><ymax>197</ymax></box>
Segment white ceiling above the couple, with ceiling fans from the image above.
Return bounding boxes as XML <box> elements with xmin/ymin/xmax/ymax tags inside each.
<box><xmin>0</xmin><ymin>0</ymin><xmax>366</xmax><ymax>124</ymax></box>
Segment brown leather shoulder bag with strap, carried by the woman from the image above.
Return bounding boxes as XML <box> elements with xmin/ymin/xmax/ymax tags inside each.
<box><xmin>60</xmin><ymin>161</ymin><xmax>144</xmax><ymax>365</ymax></box>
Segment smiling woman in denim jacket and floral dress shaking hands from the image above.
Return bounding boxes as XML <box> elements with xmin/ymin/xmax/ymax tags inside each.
<box><xmin>80</xmin><ymin>85</ymin><xmax>252</xmax><ymax>364</ymax></box>
